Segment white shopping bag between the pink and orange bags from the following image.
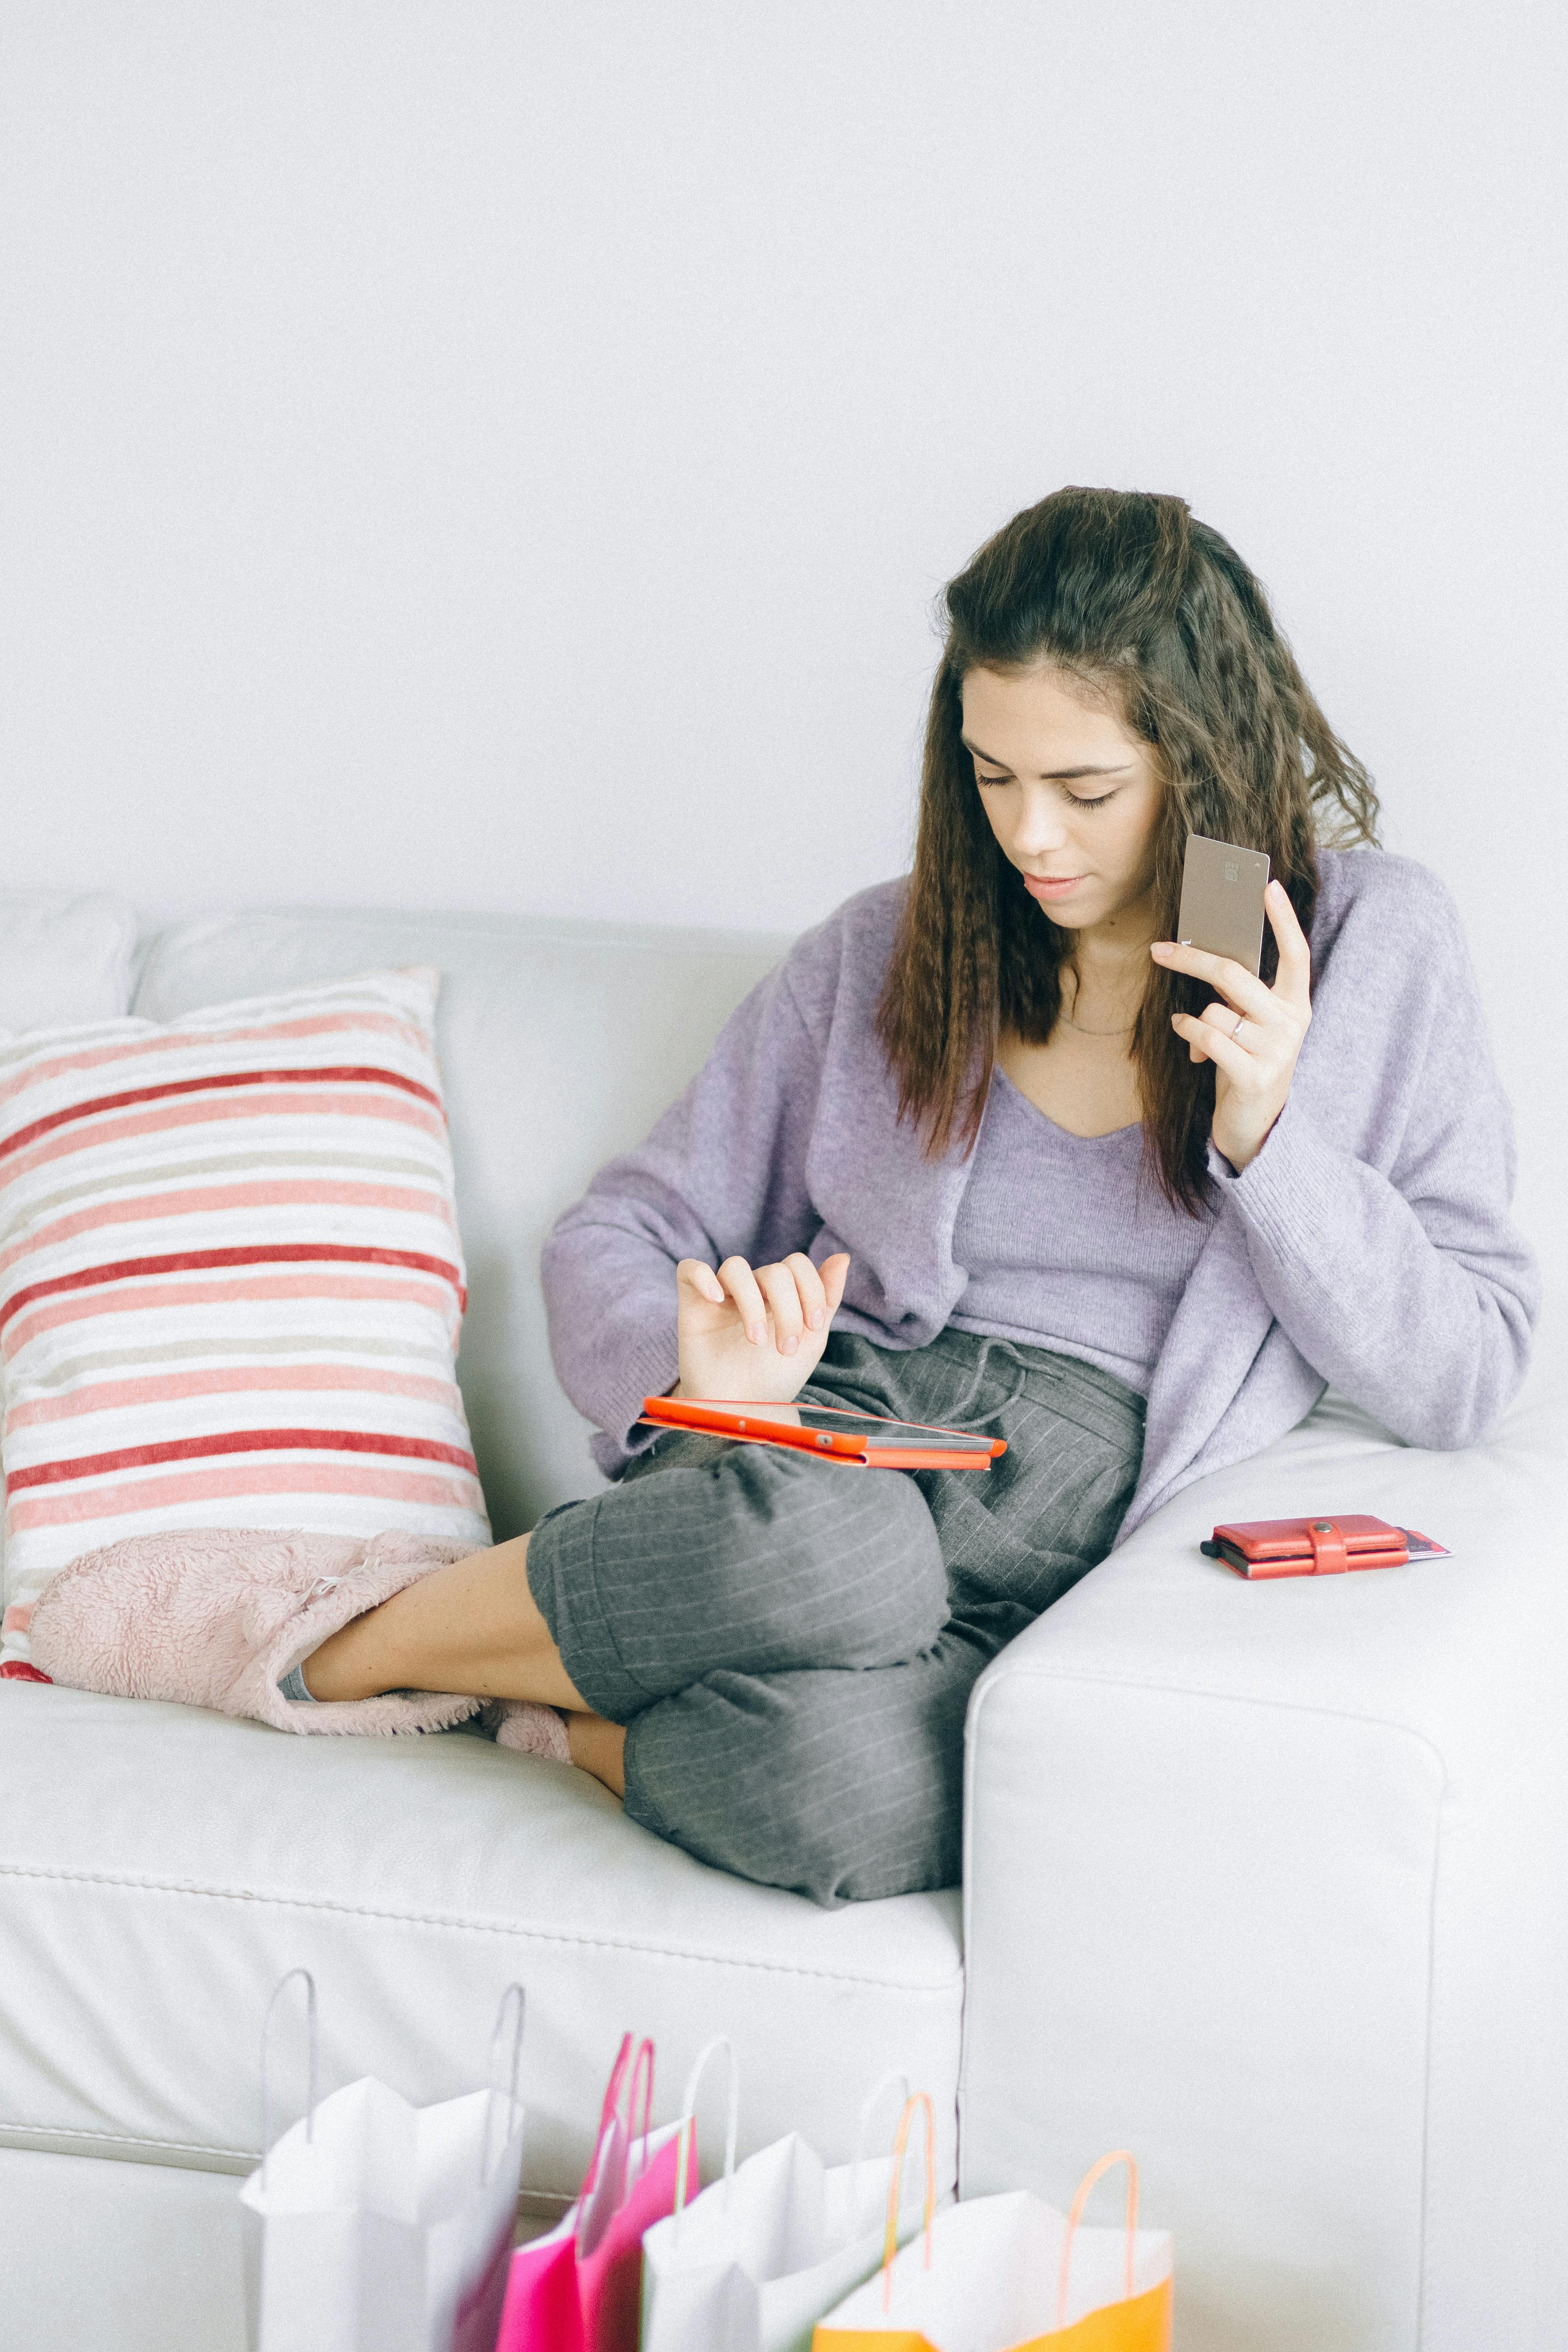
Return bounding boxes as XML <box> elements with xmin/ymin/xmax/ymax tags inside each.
<box><xmin>642</xmin><ymin>2044</ymin><xmax>940</xmax><ymax>2352</ymax></box>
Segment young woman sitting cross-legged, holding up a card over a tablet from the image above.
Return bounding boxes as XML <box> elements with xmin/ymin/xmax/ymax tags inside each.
<box><xmin>52</xmin><ymin>489</ymin><xmax>1537</xmax><ymax>1905</ymax></box>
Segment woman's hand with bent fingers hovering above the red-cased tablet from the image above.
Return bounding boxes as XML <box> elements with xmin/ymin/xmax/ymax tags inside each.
<box><xmin>670</xmin><ymin>1249</ymin><xmax>849</xmax><ymax>1404</ymax></box>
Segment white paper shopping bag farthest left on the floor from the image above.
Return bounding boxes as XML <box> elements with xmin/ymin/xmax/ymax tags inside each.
<box><xmin>240</xmin><ymin>1969</ymin><xmax>524</xmax><ymax>2352</ymax></box>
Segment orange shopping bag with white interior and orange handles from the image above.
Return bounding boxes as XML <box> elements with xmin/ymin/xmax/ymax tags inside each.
<box><xmin>811</xmin><ymin>2091</ymin><xmax>1171</xmax><ymax>2352</ymax></box>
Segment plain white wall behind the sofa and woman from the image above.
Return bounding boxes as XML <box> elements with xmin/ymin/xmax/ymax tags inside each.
<box><xmin>0</xmin><ymin>0</ymin><xmax>1568</xmax><ymax>1279</ymax></box>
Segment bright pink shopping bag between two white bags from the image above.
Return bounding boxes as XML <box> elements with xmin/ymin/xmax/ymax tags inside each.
<box><xmin>496</xmin><ymin>2035</ymin><xmax>694</xmax><ymax>2352</ymax></box>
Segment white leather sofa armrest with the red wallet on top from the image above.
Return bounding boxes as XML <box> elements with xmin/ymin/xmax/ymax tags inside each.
<box><xmin>959</xmin><ymin>1301</ymin><xmax>1568</xmax><ymax>2352</ymax></box>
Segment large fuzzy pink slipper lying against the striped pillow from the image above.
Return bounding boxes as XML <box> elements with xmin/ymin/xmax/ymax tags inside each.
<box><xmin>31</xmin><ymin>1526</ymin><xmax>484</xmax><ymax>1745</ymax></box>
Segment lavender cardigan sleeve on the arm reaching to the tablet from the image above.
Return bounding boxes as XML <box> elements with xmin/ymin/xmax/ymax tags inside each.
<box><xmin>541</xmin><ymin>941</ymin><xmax>821</xmax><ymax>1477</ymax></box>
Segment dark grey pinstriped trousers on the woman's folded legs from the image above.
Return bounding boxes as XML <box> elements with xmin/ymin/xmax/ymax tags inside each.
<box><xmin>529</xmin><ymin>1327</ymin><xmax>1143</xmax><ymax>1905</ymax></box>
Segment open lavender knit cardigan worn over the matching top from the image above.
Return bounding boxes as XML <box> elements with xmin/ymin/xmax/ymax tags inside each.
<box><xmin>543</xmin><ymin>849</ymin><xmax>1540</xmax><ymax>1541</ymax></box>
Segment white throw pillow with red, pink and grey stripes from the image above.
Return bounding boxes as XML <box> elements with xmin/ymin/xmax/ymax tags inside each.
<box><xmin>0</xmin><ymin>967</ymin><xmax>489</xmax><ymax>1663</ymax></box>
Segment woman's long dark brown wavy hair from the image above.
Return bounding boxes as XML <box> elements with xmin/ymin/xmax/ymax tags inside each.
<box><xmin>877</xmin><ymin>489</ymin><xmax>1378</xmax><ymax>1216</ymax></box>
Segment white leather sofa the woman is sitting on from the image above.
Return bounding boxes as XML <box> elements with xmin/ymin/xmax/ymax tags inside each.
<box><xmin>0</xmin><ymin>913</ymin><xmax>1568</xmax><ymax>2352</ymax></box>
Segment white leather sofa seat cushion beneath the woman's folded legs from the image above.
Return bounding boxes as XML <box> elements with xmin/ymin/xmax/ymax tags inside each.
<box><xmin>0</xmin><ymin>1682</ymin><xmax>961</xmax><ymax>2194</ymax></box>
